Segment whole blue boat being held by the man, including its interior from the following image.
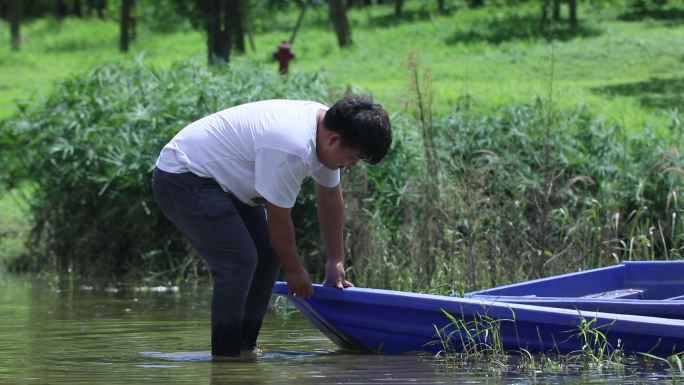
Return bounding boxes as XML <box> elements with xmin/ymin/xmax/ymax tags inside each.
<box><xmin>274</xmin><ymin>261</ymin><xmax>684</xmax><ymax>356</ymax></box>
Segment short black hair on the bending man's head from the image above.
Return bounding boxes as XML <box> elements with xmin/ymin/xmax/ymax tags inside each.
<box><xmin>323</xmin><ymin>96</ymin><xmax>392</xmax><ymax>164</ymax></box>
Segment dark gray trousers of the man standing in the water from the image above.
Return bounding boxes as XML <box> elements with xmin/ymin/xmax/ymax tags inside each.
<box><xmin>152</xmin><ymin>168</ymin><xmax>280</xmax><ymax>356</ymax></box>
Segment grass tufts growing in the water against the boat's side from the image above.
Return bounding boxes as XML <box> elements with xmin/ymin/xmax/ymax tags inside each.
<box><xmin>432</xmin><ymin>312</ymin><xmax>684</xmax><ymax>384</ymax></box>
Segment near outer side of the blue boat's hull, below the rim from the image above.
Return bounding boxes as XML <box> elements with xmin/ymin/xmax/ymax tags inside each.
<box><xmin>274</xmin><ymin>282</ymin><xmax>684</xmax><ymax>355</ymax></box>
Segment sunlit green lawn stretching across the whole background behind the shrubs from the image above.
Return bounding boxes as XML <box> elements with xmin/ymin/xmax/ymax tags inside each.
<box><xmin>0</xmin><ymin>0</ymin><xmax>684</xmax><ymax>131</ymax></box>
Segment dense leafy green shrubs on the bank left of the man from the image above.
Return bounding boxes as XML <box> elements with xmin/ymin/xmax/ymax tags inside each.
<box><xmin>0</xmin><ymin>62</ymin><xmax>328</xmax><ymax>279</ymax></box>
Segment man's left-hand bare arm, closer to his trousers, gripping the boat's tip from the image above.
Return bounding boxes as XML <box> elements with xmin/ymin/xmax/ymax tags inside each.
<box><xmin>266</xmin><ymin>203</ymin><xmax>313</xmax><ymax>297</ymax></box>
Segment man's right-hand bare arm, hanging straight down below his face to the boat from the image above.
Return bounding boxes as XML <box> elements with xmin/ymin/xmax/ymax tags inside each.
<box><xmin>316</xmin><ymin>183</ymin><xmax>354</xmax><ymax>289</ymax></box>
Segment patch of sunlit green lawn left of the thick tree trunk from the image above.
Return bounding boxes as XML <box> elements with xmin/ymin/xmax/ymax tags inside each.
<box><xmin>0</xmin><ymin>18</ymin><xmax>206</xmax><ymax>119</ymax></box>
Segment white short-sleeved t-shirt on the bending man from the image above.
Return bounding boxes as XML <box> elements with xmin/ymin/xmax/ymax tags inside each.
<box><xmin>156</xmin><ymin>100</ymin><xmax>340</xmax><ymax>208</ymax></box>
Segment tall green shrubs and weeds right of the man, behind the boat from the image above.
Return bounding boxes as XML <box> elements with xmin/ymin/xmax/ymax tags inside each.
<box><xmin>346</xmin><ymin>101</ymin><xmax>684</xmax><ymax>292</ymax></box>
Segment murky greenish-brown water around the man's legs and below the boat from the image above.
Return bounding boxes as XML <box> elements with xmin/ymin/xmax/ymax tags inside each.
<box><xmin>0</xmin><ymin>276</ymin><xmax>681</xmax><ymax>385</ymax></box>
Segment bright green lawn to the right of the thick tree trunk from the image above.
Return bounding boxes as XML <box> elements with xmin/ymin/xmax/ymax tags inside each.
<box><xmin>250</xmin><ymin>2</ymin><xmax>684</xmax><ymax>134</ymax></box>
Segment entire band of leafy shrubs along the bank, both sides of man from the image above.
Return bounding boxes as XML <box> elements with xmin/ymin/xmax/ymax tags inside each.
<box><xmin>0</xmin><ymin>62</ymin><xmax>684</xmax><ymax>292</ymax></box>
